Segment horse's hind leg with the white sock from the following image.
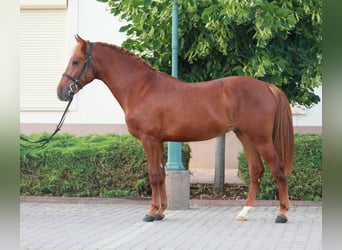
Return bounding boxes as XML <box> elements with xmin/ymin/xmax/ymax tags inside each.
<box><xmin>235</xmin><ymin>131</ymin><xmax>264</xmax><ymax>221</ymax></box>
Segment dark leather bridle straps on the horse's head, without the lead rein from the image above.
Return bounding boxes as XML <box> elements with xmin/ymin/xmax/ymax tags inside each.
<box><xmin>63</xmin><ymin>42</ymin><xmax>96</xmax><ymax>96</ymax></box>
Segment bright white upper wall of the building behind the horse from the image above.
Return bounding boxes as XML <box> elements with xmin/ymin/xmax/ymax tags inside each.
<box><xmin>20</xmin><ymin>0</ymin><xmax>322</xmax><ymax>126</ymax></box>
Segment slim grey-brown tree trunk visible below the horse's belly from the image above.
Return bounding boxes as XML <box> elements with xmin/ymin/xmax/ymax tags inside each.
<box><xmin>214</xmin><ymin>134</ymin><xmax>226</xmax><ymax>193</ymax></box>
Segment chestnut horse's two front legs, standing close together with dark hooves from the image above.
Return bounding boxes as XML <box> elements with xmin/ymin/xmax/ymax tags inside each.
<box><xmin>142</xmin><ymin>137</ymin><xmax>167</xmax><ymax>222</ymax></box>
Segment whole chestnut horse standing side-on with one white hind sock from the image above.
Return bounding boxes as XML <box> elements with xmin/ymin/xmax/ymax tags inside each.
<box><xmin>57</xmin><ymin>35</ymin><xmax>294</xmax><ymax>223</ymax></box>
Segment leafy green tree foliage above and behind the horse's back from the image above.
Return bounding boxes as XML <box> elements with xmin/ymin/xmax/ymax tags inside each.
<box><xmin>98</xmin><ymin>0</ymin><xmax>322</xmax><ymax>106</ymax></box>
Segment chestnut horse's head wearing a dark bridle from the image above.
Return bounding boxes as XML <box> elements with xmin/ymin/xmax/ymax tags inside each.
<box><xmin>57</xmin><ymin>35</ymin><xmax>96</xmax><ymax>101</ymax></box>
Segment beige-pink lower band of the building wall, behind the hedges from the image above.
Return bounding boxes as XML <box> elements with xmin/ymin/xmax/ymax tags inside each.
<box><xmin>20</xmin><ymin>123</ymin><xmax>322</xmax><ymax>169</ymax></box>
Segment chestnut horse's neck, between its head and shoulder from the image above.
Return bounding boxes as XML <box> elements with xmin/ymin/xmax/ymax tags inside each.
<box><xmin>97</xmin><ymin>44</ymin><xmax>155</xmax><ymax>112</ymax></box>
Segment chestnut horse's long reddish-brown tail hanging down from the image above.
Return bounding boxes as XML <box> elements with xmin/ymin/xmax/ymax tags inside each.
<box><xmin>269</xmin><ymin>84</ymin><xmax>294</xmax><ymax>175</ymax></box>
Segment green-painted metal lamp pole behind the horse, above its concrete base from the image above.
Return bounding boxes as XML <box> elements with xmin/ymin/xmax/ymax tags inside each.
<box><xmin>166</xmin><ymin>0</ymin><xmax>185</xmax><ymax>171</ymax></box>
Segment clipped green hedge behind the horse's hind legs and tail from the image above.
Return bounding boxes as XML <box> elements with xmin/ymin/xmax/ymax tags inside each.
<box><xmin>239</xmin><ymin>134</ymin><xmax>322</xmax><ymax>201</ymax></box>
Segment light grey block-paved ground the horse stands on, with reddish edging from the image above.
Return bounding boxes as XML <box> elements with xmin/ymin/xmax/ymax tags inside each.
<box><xmin>20</xmin><ymin>197</ymin><xmax>322</xmax><ymax>250</ymax></box>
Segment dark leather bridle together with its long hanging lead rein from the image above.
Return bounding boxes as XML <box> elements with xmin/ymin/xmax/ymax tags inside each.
<box><xmin>20</xmin><ymin>42</ymin><xmax>96</xmax><ymax>148</ymax></box>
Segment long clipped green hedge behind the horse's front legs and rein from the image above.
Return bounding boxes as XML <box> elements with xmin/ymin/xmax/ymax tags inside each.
<box><xmin>20</xmin><ymin>134</ymin><xmax>190</xmax><ymax>197</ymax></box>
